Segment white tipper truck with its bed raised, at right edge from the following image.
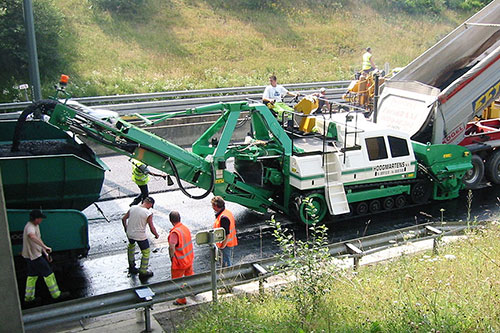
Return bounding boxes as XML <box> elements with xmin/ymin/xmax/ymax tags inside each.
<box><xmin>374</xmin><ymin>0</ymin><xmax>500</xmax><ymax>188</ymax></box>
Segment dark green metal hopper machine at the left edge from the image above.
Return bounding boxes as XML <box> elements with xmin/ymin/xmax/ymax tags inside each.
<box><xmin>0</xmin><ymin>121</ymin><xmax>107</xmax><ymax>256</ymax></box>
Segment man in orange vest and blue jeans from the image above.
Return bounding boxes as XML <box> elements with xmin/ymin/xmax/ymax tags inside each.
<box><xmin>212</xmin><ymin>196</ymin><xmax>238</xmax><ymax>267</ymax></box>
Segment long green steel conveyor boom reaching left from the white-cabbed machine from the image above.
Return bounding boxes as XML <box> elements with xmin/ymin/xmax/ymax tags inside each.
<box><xmin>38</xmin><ymin>100</ymin><xmax>292</xmax><ymax>214</ymax></box>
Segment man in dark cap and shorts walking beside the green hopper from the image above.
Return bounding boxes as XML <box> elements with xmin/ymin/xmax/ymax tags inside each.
<box><xmin>22</xmin><ymin>209</ymin><xmax>70</xmax><ymax>306</ymax></box>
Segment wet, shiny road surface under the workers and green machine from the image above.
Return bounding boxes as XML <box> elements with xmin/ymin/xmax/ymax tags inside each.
<box><xmin>18</xmin><ymin>156</ymin><xmax>500</xmax><ymax>302</ymax></box>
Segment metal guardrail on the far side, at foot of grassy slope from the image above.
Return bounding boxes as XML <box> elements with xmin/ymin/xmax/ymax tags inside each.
<box><xmin>0</xmin><ymin>81</ymin><xmax>351</xmax><ymax>112</ymax></box>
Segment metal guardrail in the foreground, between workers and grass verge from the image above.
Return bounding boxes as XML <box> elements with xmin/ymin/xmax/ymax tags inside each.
<box><xmin>23</xmin><ymin>222</ymin><xmax>475</xmax><ymax>330</ymax></box>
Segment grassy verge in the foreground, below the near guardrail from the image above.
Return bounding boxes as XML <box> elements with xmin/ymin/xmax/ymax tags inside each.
<box><xmin>177</xmin><ymin>222</ymin><xmax>500</xmax><ymax>333</ymax></box>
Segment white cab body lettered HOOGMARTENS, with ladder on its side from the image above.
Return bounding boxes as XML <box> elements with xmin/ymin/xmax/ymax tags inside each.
<box><xmin>290</xmin><ymin>113</ymin><xmax>417</xmax><ymax>215</ymax></box>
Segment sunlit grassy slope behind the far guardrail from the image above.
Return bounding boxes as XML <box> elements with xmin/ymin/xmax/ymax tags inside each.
<box><xmin>22</xmin><ymin>0</ymin><xmax>468</xmax><ymax>96</ymax></box>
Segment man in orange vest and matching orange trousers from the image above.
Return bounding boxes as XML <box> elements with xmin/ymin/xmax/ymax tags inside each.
<box><xmin>168</xmin><ymin>211</ymin><xmax>194</xmax><ymax>305</ymax></box>
